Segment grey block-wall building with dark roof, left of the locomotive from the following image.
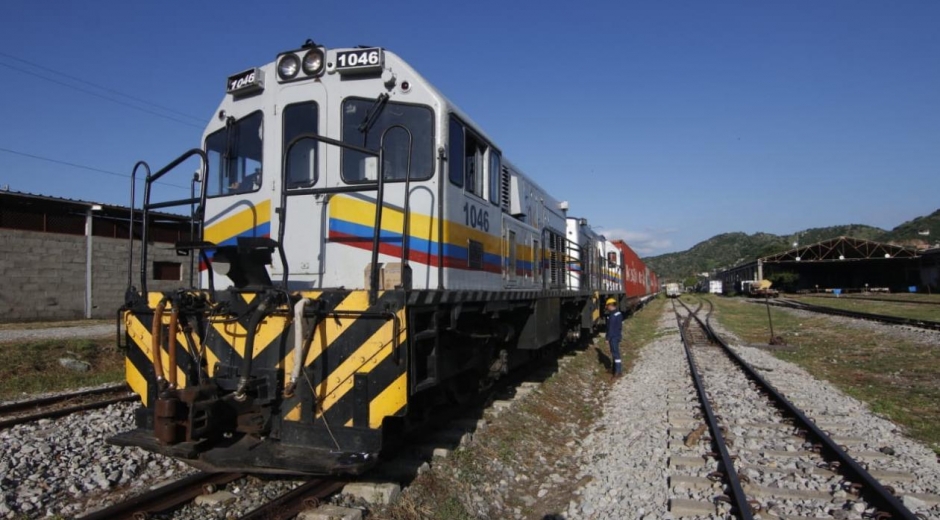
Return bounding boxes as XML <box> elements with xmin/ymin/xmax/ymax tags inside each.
<box><xmin>0</xmin><ymin>191</ymin><xmax>192</xmax><ymax>322</ymax></box>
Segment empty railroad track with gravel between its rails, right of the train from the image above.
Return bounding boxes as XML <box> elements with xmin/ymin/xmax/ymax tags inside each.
<box><xmin>673</xmin><ymin>301</ymin><xmax>918</xmax><ymax>520</ymax></box>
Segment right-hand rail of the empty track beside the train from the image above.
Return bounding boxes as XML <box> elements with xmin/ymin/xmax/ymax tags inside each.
<box><xmin>694</xmin><ymin>301</ymin><xmax>917</xmax><ymax>520</ymax></box>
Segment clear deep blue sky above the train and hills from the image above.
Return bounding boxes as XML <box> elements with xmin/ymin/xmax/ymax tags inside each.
<box><xmin>0</xmin><ymin>0</ymin><xmax>940</xmax><ymax>254</ymax></box>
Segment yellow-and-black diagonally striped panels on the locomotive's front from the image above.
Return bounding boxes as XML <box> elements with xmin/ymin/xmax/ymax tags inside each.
<box><xmin>124</xmin><ymin>289</ymin><xmax>408</xmax><ymax>434</ymax></box>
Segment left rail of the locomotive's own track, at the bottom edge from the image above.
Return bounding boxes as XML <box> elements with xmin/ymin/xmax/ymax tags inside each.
<box><xmin>77</xmin><ymin>473</ymin><xmax>244</xmax><ymax>520</ymax></box>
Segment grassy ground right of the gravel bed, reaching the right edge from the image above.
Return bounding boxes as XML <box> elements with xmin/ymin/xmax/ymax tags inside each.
<box><xmin>710</xmin><ymin>297</ymin><xmax>940</xmax><ymax>453</ymax></box>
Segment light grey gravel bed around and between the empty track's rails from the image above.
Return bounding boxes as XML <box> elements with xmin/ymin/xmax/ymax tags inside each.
<box><xmin>567</xmin><ymin>304</ymin><xmax>940</xmax><ymax>520</ymax></box>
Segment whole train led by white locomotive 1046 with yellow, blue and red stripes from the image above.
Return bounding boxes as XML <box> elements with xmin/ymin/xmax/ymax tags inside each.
<box><xmin>117</xmin><ymin>41</ymin><xmax>659</xmax><ymax>474</ymax></box>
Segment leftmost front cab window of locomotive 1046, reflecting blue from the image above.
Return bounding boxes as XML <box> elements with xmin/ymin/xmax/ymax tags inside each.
<box><xmin>206</xmin><ymin>112</ymin><xmax>263</xmax><ymax>197</ymax></box>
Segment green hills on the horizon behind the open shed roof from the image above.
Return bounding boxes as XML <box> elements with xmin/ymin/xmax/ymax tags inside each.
<box><xmin>643</xmin><ymin>209</ymin><xmax>940</xmax><ymax>280</ymax></box>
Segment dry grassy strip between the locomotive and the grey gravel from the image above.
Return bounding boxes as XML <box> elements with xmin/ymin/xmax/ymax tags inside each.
<box><xmin>370</xmin><ymin>298</ymin><xmax>665</xmax><ymax>520</ymax></box>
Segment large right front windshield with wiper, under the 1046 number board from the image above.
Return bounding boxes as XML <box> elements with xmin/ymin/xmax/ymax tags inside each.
<box><xmin>343</xmin><ymin>99</ymin><xmax>434</xmax><ymax>183</ymax></box>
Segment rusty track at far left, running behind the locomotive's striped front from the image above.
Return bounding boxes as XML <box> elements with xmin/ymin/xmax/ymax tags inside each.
<box><xmin>0</xmin><ymin>383</ymin><xmax>136</xmax><ymax>429</ymax></box>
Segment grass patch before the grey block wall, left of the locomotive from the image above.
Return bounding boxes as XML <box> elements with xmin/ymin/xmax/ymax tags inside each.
<box><xmin>0</xmin><ymin>338</ymin><xmax>124</xmax><ymax>400</ymax></box>
